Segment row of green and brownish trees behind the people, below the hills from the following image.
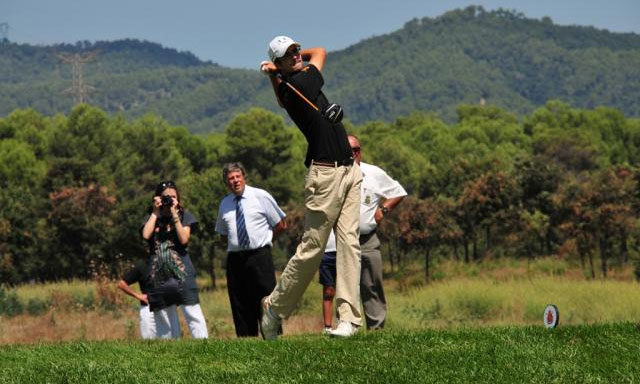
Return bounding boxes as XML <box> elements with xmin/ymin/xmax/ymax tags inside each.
<box><xmin>0</xmin><ymin>101</ymin><xmax>640</xmax><ymax>283</ymax></box>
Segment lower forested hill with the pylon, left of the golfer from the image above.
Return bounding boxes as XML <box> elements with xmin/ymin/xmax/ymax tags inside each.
<box><xmin>0</xmin><ymin>40</ymin><xmax>264</xmax><ymax>132</ymax></box>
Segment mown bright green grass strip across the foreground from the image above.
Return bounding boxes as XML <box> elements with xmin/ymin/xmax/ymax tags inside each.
<box><xmin>0</xmin><ymin>323</ymin><xmax>640</xmax><ymax>384</ymax></box>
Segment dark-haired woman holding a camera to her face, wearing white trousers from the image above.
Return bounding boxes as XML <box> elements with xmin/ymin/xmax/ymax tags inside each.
<box><xmin>142</xmin><ymin>181</ymin><xmax>208</xmax><ymax>339</ymax></box>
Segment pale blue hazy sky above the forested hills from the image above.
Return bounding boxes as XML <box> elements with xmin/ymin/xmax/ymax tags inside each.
<box><xmin>0</xmin><ymin>0</ymin><xmax>640</xmax><ymax>68</ymax></box>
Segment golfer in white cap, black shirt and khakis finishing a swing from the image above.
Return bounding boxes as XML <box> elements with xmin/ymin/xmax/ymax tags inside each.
<box><xmin>260</xmin><ymin>36</ymin><xmax>362</xmax><ymax>339</ymax></box>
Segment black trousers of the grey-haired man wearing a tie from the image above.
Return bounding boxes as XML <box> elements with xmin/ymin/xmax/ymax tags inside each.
<box><xmin>227</xmin><ymin>246</ymin><xmax>276</xmax><ymax>337</ymax></box>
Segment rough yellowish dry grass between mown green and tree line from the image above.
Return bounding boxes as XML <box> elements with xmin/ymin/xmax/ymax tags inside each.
<box><xmin>6</xmin><ymin>258</ymin><xmax>640</xmax><ymax>344</ymax></box>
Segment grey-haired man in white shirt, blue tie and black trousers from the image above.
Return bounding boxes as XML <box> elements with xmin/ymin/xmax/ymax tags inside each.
<box><xmin>216</xmin><ymin>163</ymin><xmax>287</xmax><ymax>337</ymax></box>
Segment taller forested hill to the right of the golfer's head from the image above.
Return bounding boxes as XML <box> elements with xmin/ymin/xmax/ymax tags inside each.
<box><xmin>326</xmin><ymin>7</ymin><xmax>640</xmax><ymax>122</ymax></box>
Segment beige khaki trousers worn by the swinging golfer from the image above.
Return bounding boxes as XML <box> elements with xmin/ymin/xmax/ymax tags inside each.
<box><xmin>270</xmin><ymin>163</ymin><xmax>362</xmax><ymax>326</ymax></box>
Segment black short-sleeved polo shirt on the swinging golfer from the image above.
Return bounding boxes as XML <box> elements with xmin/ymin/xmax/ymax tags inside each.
<box><xmin>278</xmin><ymin>64</ymin><xmax>352</xmax><ymax>167</ymax></box>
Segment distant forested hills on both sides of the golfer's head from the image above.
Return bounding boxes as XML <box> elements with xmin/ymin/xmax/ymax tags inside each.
<box><xmin>0</xmin><ymin>7</ymin><xmax>640</xmax><ymax>133</ymax></box>
